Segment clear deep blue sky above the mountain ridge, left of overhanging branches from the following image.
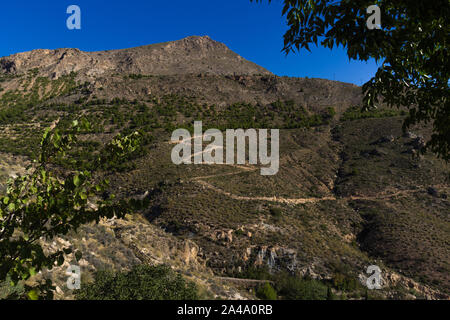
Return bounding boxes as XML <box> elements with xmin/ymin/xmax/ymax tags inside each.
<box><xmin>0</xmin><ymin>0</ymin><xmax>376</xmax><ymax>85</ymax></box>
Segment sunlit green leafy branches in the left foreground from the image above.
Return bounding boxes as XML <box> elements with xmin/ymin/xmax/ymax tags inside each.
<box><xmin>0</xmin><ymin>121</ymin><xmax>147</xmax><ymax>299</ymax></box>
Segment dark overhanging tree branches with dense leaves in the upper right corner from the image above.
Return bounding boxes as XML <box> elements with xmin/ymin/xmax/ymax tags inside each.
<box><xmin>255</xmin><ymin>0</ymin><xmax>450</xmax><ymax>161</ymax></box>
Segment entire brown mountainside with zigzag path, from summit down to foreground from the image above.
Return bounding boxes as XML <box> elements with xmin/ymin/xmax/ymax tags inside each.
<box><xmin>0</xmin><ymin>37</ymin><xmax>450</xmax><ymax>299</ymax></box>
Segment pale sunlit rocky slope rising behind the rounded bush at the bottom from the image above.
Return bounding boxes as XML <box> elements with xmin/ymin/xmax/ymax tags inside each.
<box><xmin>28</xmin><ymin>218</ymin><xmax>253</xmax><ymax>300</ymax></box>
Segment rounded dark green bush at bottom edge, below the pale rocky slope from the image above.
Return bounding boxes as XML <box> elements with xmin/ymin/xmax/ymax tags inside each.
<box><xmin>76</xmin><ymin>265</ymin><xmax>198</xmax><ymax>300</ymax></box>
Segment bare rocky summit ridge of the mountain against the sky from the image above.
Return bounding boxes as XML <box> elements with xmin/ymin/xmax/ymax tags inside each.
<box><xmin>0</xmin><ymin>36</ymin><xmax>271</xmax><ymax>79</ymax></box>
